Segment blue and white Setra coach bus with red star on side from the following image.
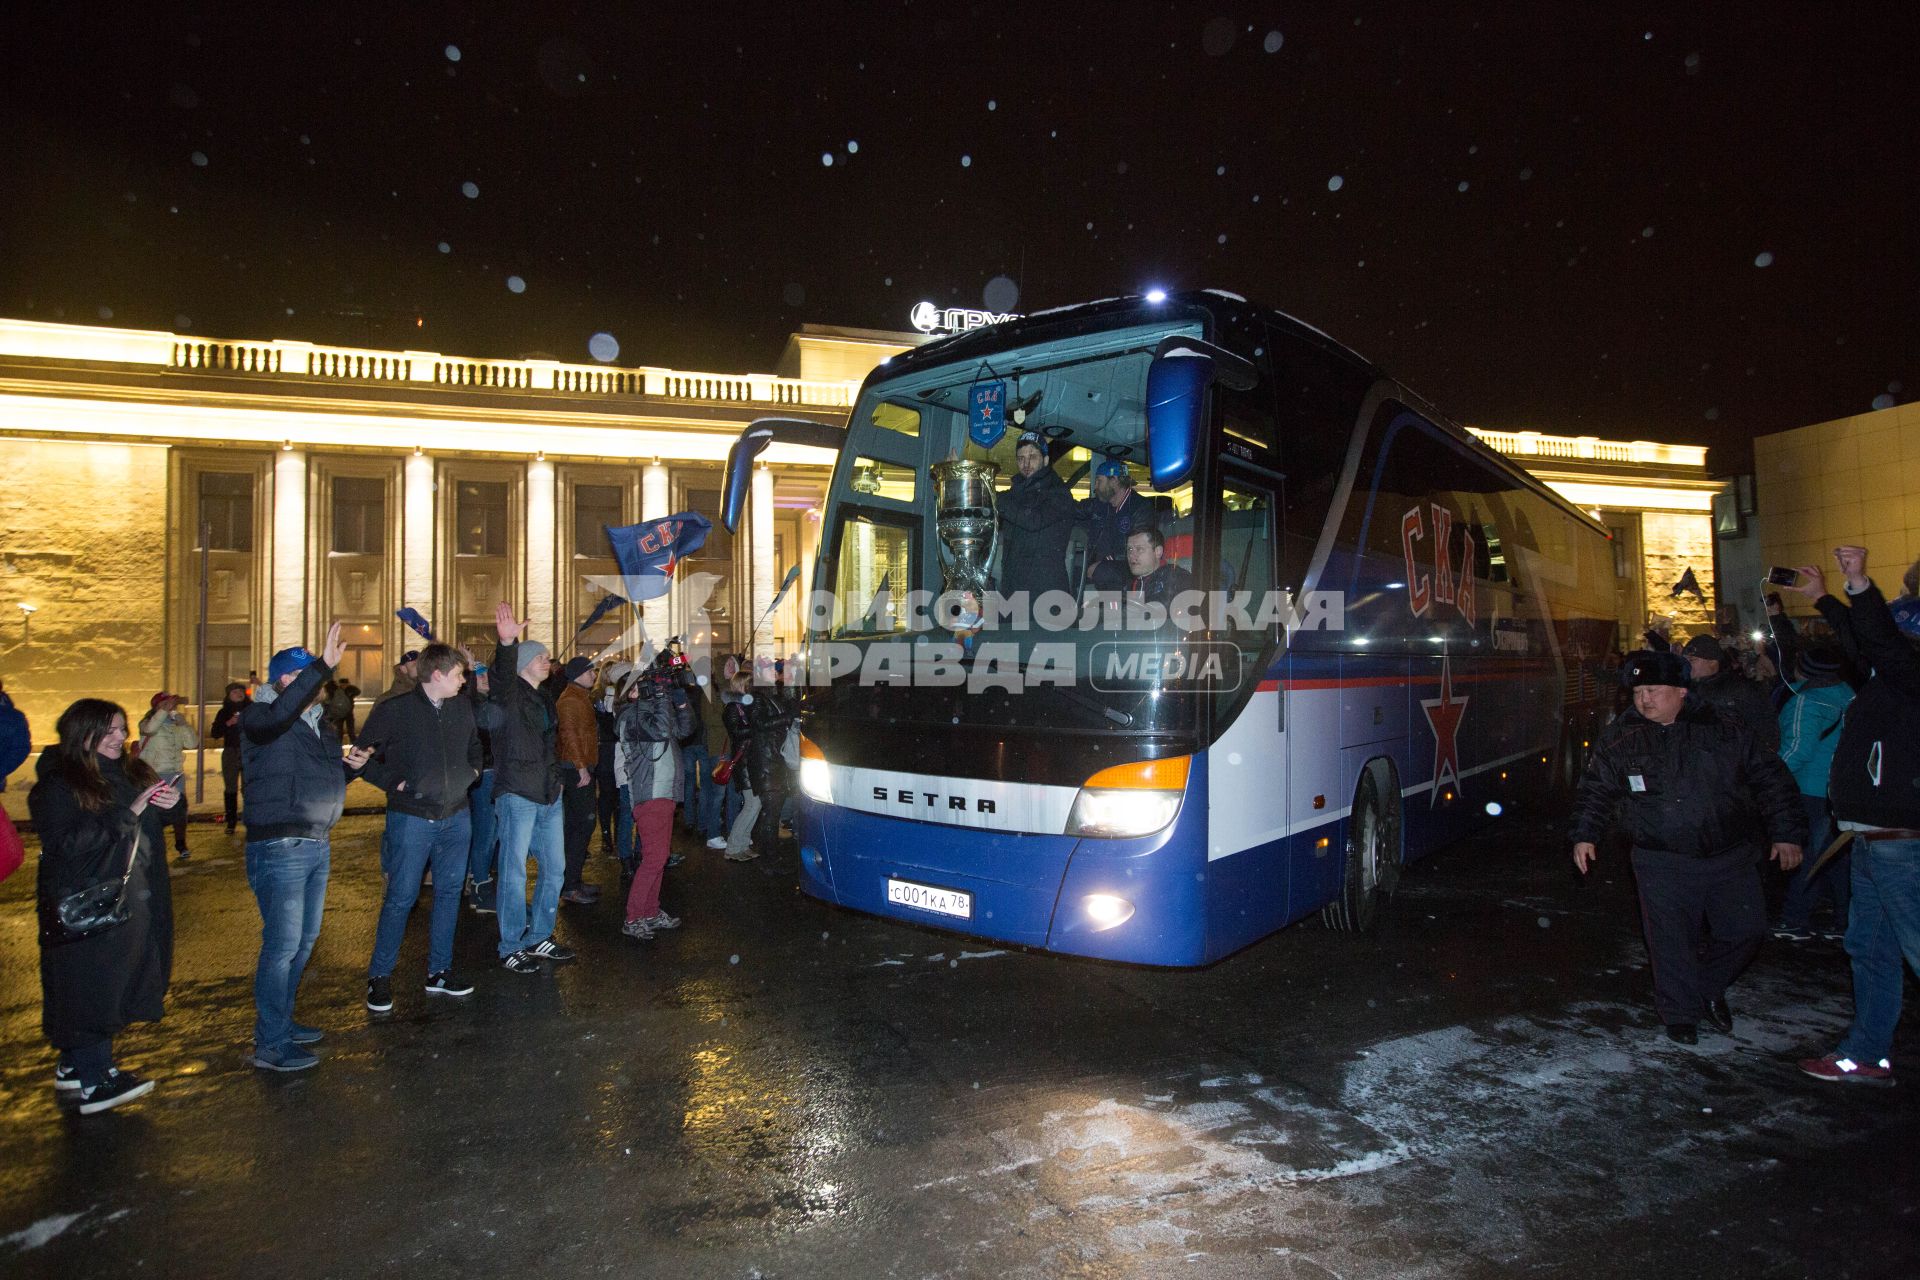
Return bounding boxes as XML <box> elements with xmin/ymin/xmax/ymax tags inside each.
<box><xmin>722</xmin><ymin>292</ymin><xmax>1615</xmax><ymax>965</ymax></box>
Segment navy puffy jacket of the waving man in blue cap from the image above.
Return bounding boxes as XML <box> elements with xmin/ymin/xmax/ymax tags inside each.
<box><xmin>240</xmin><ymin>660</ymin><xmax>349</xmax><ymax>844</ymax></box>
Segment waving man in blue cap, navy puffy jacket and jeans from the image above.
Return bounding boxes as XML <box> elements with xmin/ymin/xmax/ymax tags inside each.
<box><xmin>240</xmin><ymin>622</ymin><xmax>371</xmax><ymax>1071</ymax></box>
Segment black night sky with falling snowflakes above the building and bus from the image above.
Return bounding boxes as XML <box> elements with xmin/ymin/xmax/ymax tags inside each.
<box><xmin>0</xmin><ymin>0</ymin><xmax>1920</xmax><ymax>454</ymax></box>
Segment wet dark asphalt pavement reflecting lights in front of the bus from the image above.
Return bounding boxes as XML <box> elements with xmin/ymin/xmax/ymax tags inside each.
<box><xmin>0</xmin><ymin>805</ymin><xmax>1920</xmax><ymax>1280</ymax></box>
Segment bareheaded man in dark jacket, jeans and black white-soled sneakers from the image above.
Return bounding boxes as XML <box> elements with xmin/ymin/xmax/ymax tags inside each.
<box><xmin>359</xmin><ymin>645</ymin><xmax>482</xmax><ymax>1013</ymax></box>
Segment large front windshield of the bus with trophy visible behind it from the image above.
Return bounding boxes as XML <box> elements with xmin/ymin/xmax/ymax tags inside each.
<box><xmin>806</xmin><ymin>320</ymin><xmax>1217</xmax><ymax>733</ymax></box>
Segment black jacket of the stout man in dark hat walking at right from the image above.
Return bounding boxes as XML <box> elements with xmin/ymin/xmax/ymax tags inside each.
<box><xmin>1572</xmin><ymin>697</ymin><xmax>1807</xmax><ymax>858</ymax></box>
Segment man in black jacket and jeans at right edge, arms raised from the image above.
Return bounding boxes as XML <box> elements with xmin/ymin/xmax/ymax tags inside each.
<box><xmin>1795</xmin><ymin>547</ymin><xmax>1920</xmax><ymax>1084</ymax></box>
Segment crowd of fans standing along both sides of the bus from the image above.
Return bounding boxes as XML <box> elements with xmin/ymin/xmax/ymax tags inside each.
<box><xmin>0</xmin><ymin>547</ymin><xmax>1920</xmax><ymax>1113</ymax></box>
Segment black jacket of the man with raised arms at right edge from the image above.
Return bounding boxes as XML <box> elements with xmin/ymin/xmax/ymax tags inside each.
<box><xmin>1814</xmin><ymin>583</ymin><xmax>1920</xmax><ymax>829</ymax></box>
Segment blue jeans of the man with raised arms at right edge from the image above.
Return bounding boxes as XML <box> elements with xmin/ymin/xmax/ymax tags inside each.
<box><xmin>1839</xmin><ymin>839</ymin><xmax>1920</xmax><ymax>1063</ymax></box>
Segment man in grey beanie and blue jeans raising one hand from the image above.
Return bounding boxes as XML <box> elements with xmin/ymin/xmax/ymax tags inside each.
<box><xmin>480</xmin><ymin>601</ymin><xmax>578</xmax><ymax>973</ymax></box>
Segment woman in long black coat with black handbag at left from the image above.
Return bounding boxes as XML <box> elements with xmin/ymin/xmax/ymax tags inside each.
<box><xmin>27</xmin><ymin>699</ymin><xmax>180</xmax><ymax>1115</ymax></box>
